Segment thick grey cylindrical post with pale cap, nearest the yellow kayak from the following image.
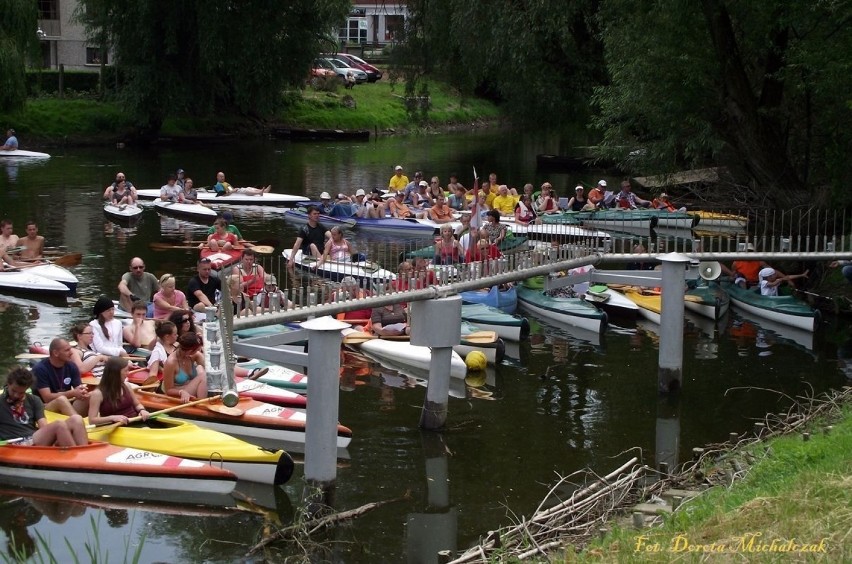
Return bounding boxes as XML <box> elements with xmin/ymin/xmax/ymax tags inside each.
<box><xmin>301</xmin><ymin>316</ymin><xmax>349</xmax><ymax>489</ymax></box>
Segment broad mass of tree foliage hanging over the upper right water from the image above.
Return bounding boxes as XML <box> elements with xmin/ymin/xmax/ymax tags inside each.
<box><xmin>399</xmin><ymin>0</ymin><xmax>852</xmax><ymax>203</ymax></box>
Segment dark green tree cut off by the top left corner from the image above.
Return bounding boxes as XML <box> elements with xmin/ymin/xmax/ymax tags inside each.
<box><xmin>0</xmin><ymin>0</ymin><xmax>38</xmax><ymax>111</ymax></box>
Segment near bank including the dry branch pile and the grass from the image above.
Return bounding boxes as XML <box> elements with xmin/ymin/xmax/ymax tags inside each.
<box><xmin>450</xmin><ymin>386</ymin><xmax>852</xmax><ymax>564</ymax></box>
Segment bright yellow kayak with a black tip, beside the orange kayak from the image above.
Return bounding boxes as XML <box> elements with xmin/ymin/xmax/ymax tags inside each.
<box><xmin>45</xmin><ymin>411</ymin><xmax>293</xmax><ymax>485</ymax></box>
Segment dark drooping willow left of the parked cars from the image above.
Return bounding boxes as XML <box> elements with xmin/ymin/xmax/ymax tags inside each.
<box><xmin>76</xmin><ymin>0</ymin><xmax>351</xmax><ymax>135</ymax></box>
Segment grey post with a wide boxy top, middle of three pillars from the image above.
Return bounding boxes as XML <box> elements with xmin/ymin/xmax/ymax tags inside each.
<box><xmin>410</xmin><ymin>295</ymin><xmax>461</xmax><ymax>430</ymax></box>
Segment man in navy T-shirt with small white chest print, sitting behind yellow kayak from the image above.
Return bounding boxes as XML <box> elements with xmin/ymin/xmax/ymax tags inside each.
<box><xmin>33</xmin><ymin>337</ymin><xmax>89</xmax><ymax>416</ymax></box>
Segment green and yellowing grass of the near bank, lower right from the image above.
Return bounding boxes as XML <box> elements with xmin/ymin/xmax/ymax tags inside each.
<box><xmin>567</xmin><ymin>405</ymin><xmax>852</xmax><ymax>562</ymax></box>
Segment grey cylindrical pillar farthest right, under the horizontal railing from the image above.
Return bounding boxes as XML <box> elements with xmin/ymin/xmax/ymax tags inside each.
<box><xmin>658</xmin><ymin>253</ymin><xmax>689</xmax><ymax>393</ymax></box>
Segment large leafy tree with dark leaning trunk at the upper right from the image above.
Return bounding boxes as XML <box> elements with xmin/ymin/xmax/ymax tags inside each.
<box><xmin>596</xmin><ymin>0</ymin><xmax>852</xmax><ymax>207</ymax></box>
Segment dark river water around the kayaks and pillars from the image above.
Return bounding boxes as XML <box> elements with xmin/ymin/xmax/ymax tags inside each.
<box><xmin>0</xmin><ymin>131</ymin><xmax>852</xmax><ymax>562</ymax></box>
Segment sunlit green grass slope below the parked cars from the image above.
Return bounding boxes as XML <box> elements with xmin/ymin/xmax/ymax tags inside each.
<box><xmin>279</xmin><ymin>79</ymin><xmax>500</xmax><ymax>129</ymax></box>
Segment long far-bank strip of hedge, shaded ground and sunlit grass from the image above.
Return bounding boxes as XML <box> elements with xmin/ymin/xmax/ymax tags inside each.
<box><xmin>0</xmin><ymin>79</ymin><xmax>502</xmax><ymax>149</ymax></box>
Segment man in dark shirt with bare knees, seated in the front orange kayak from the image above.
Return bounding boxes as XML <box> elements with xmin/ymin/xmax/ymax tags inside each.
<box><xmin>0</xmin><ymin>366</ymin><xmax>89</xmax><ymax>447</ymax></box>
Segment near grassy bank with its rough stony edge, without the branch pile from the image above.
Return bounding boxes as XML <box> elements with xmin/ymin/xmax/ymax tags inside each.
<box><xmin>563</xmin><ymin>386</ymin><xmax>852</xmax><ymax>562</ymax></box>
